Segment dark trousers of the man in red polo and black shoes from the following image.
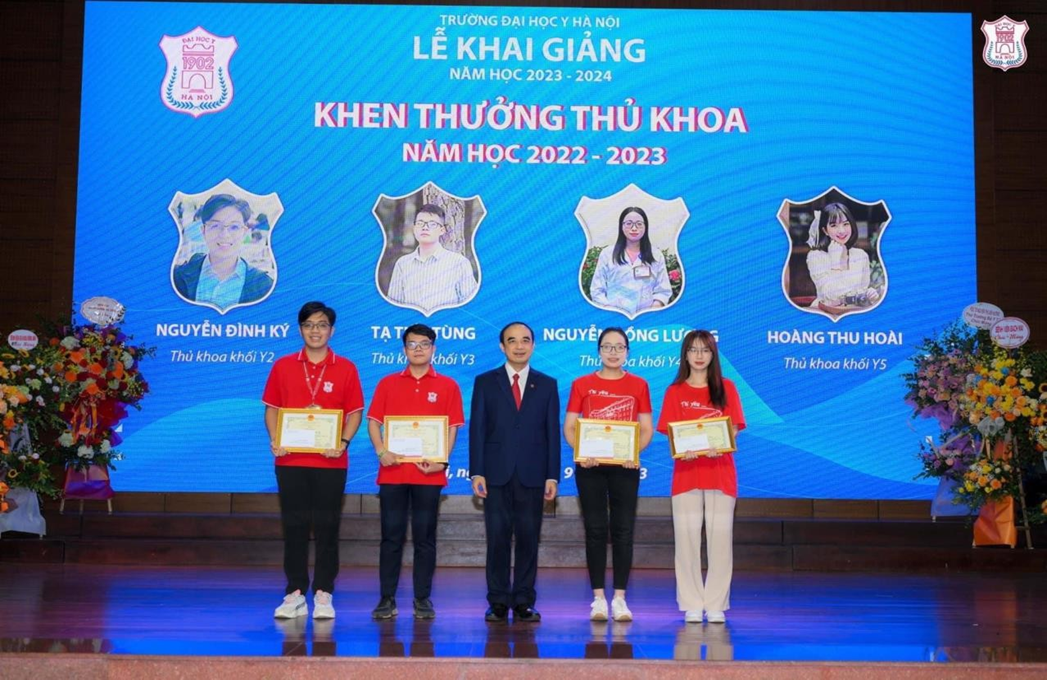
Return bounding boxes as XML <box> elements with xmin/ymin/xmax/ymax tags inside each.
<box><xmin>378</xmin><ymin>484</ymin><xmax>443</xmax><ymax>599</ymax></box>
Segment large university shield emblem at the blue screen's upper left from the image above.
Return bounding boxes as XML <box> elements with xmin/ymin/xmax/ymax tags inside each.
<box><xmin>160</xmin><ymin>26</ymin><xmax>237</xmax><ymax>118</ymax></box>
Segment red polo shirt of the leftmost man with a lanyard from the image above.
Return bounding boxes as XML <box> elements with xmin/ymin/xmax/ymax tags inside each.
<box><xmin>262</xmin><ymin>348</ymin><xmax>363</xmax><ymax>469</ymax></box>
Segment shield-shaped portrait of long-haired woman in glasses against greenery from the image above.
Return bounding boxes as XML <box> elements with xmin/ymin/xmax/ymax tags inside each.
<box><xmin>575</xmin><ymin>184</ymin><xmax>689</xmax><ymax>320</ymax></box>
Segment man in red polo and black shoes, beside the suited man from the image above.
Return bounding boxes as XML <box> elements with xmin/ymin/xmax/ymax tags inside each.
<box><xmin>367</xmin><ymin>324</ymin><xmax>465</xmax><ymax>619</ymax></box>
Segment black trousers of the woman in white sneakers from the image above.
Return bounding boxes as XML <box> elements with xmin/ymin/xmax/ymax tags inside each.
<box><xmin>575</xmin><ymin>465</ymin><xmax>640</xmax><ymax>590</ymax></box>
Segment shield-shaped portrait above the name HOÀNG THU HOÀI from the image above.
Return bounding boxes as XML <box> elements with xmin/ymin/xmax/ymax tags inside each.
<box><xmin>778</xmin><ymin>187</ymin><xmax>891</xmax><ymax>321</ymax></box>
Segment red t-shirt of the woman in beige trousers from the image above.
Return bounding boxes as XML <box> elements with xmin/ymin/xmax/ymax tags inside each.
<box><xmin>658</xmin><ymin>378</ymin><xmax>745</xmax><ymax>498</ymax></box>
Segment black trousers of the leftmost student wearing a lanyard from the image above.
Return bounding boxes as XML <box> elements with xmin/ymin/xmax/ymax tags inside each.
<box><xmin>276</xmin><ymin>465</ymin><xmax>347</xmax><ymax>593</ymax></box>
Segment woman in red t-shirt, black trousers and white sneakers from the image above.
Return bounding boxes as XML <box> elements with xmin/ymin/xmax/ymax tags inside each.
<box><xmin>563</xmin><ymin>328</ymin><xmax>654</xmax><ymax>621</ymax></box>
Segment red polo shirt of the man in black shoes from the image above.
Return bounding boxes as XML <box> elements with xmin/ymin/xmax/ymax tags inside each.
<box><xmin>367</xmin><ymin>366</ymin><xmax>465</xmax><ymax>486</ymax></box>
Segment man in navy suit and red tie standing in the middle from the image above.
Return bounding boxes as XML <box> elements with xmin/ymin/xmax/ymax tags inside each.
<box><xmin>469</xmin><ymin>322</ymin><xmax>560</xmax><ymax>622</ymax></box>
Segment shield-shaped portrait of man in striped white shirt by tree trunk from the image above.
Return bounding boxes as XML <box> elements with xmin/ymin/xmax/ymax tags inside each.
<box><xmin>374</xmin><ymin>182</ymin><xmax>487</xmax><ymax>316</ymax></box>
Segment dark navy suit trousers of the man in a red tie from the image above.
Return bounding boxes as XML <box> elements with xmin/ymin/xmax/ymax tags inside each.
<box><xmin>484</xmin><ymin>474</ymin><xmax>545</xmax><ymax>607</ymax></box>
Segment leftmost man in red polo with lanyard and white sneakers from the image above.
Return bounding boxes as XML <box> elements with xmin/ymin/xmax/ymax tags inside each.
<box><xmin>262</xmin><ymin>302</ymin><xmax>363</xmax><ymax>618</ymax></box>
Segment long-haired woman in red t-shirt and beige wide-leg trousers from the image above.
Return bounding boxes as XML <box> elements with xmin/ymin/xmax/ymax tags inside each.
<box><xmin>658</xmin><ymin>330</ymin><xmax>745</xmax><ymax>623</ymax></box>
